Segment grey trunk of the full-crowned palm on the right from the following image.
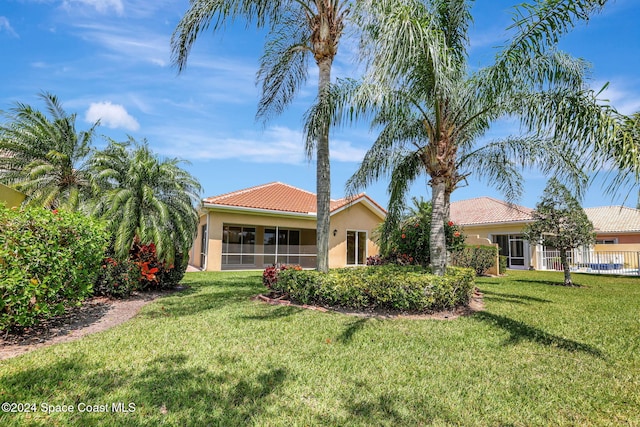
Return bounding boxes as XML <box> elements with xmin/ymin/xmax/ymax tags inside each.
<box><xmin>429</xmin><ymin>178</ymin><xmax>447</xmax><ymax>276</ymax></box>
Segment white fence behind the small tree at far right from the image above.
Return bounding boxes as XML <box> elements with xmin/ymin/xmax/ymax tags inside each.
<box><xmin>538</xmin><ymin>249</ymin><xmax>640</xmax><ymax>275</ymax></box>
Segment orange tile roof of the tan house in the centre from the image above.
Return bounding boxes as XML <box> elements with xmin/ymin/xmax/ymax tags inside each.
<box><xmin>203</xmin><ymin>182</ymin><xmax>385</xmax><ymax>216</ymax></box>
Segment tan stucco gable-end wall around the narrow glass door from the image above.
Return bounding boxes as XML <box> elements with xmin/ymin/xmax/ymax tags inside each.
<box><xmin>329</xmin><ymin>203</ymin><xmax>383</xmax><ymax>268</ymax></box>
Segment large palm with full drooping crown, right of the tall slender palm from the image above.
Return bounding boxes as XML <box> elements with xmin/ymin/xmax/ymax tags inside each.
<box><xmin>306</xmin><ymin>0</ymin><xmax>611</xmax><ymax>275</ymax></box>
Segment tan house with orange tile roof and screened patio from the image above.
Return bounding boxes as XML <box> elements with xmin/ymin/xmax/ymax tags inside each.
<box><xmin>189</xmin><ymin>182</ymin><xmax>386</xmax><ymax>271</ymax></box>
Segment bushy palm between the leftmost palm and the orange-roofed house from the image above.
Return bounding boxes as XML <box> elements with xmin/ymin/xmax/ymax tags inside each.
<box><xmin>90</xmin><ymin>138</ymin><xmax>201</xmax><ymax>264</ymax></box>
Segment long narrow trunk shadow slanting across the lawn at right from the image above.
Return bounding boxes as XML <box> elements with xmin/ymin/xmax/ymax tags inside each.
<box><xmin>473</xmin><ymin>311</ymin><xmax>607</xmax><ymax>360</ymax></box>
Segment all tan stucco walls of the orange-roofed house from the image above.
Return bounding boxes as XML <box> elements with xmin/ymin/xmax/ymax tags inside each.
<box><xmin>190</xmin><ymin>203</ymin><xmax>382</xmax><ymax>271</ymax></box>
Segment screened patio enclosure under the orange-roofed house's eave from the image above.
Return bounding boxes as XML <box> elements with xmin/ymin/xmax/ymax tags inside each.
<box><xmin>222</xmin><ymin>224</ymin><xmax>317</xmax><ymax>270</ymax></box>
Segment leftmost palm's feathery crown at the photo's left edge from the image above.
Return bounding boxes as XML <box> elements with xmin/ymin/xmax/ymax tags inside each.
<box><xmin>0</xmin><ymin>93</ymin><xmax>99</xmax><ymax>210</ymax></box>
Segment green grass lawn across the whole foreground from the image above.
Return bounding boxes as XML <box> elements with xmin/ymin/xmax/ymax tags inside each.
<box><xmin>0</xmin><ymin>272</ymin><xmax>640</xmax><ymax>426</ymax></box>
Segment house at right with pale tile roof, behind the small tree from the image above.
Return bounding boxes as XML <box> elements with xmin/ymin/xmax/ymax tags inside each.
<box><xmin>450</xmin><ymin>197</ymin><xmax>640</xmax><ymax>269</ymax></box>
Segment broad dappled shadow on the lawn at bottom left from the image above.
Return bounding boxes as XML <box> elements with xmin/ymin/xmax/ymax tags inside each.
<box><xmin>0</xmin><ymin>354</ymin><xmax>290</xmax><ymax>426</ymax></box>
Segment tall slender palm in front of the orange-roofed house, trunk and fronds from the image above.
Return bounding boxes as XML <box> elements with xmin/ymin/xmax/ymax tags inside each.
<box><xmin>171</xmin><ymin>0</ymin><xmax>351</xmax><ymax>272</ymax></box>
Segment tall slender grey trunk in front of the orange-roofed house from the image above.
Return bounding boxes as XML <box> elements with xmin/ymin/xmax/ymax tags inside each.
<box><xmin>316</xmin><ymin>57</ymin><xmax>332</xmax><ymax>273</ymax></box>
